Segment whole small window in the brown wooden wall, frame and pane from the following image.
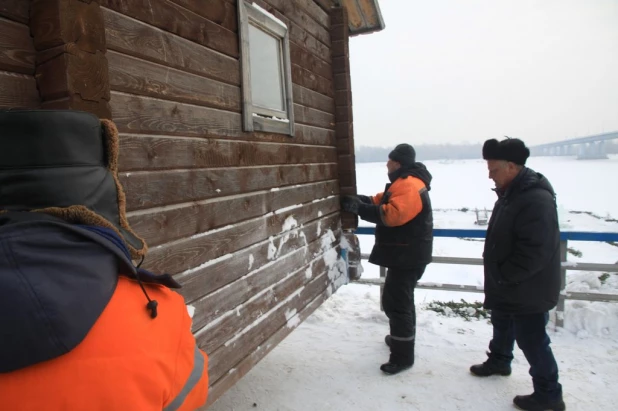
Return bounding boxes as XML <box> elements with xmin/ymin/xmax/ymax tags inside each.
<box><xmin>238</xmin><ymin>0</ymin><xmax>294</xmax><ymax>136</ymax></box>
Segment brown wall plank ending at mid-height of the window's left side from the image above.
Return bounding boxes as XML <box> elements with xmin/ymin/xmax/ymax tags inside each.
<box><xmin>102</xmin><ymin>8</ymin><xmax>240</xmax><ymax>85</ymax></box>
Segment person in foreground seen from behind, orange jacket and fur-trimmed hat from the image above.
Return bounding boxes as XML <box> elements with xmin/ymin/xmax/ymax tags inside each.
<box><xmin>0</xmin><ymin>110</ymin><xmax>208</xmax><ymax>411</ymax></box>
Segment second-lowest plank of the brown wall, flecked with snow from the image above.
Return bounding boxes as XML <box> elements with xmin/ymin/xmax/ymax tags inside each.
<box><xmin>206</xmin><ymin>264</ymin><xmax>342</xmax><ymax>383</ymax></box>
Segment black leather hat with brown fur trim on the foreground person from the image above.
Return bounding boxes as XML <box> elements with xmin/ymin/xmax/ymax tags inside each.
<box><xmin>0</xmin><ymin>110</ymin><xmax>147</xmax><ymax>260</ymax></box>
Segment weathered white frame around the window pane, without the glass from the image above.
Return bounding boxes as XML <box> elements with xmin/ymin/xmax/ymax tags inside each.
<box><xmin>238</xmin><ymin>0</ymin><xmax>295</xmax><ymax>136</ymax></box>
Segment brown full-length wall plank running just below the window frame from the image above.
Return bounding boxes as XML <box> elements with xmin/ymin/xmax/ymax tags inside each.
<box><xmin>120</xmin><ymin>135</ymin><xmax>337</xmax><ymax>171</ymax></box>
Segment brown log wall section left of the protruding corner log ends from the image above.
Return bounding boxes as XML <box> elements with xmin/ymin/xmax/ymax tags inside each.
<box><xmin>0</xmin><ymin>0</ymin><xmax>41</xmax><ymax>109</ymax></box>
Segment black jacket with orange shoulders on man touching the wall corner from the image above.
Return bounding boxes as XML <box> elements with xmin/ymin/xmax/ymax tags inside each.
<box><xmin>358</xmin><ymin>163</ymin><xmax>433</xmax><ymax>269</ymax></box>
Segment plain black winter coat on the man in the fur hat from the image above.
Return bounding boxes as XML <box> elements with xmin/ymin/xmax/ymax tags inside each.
<box><xmin>483</xmin><ymin>168</ymin><xmax>560</xmax><ymax>314</ymax></box>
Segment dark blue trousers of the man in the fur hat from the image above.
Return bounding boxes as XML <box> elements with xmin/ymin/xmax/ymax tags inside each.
<box><xmin>489</xmin><ymin>310</ymin><xmax>562</xmax><ymax>400</ymax></box>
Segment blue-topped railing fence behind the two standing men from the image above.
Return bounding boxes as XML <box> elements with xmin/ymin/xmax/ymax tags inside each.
<box><xmin>355</xmin><ymin>227</ymin><xmax>618</xmax><ymax>327</ymax></box>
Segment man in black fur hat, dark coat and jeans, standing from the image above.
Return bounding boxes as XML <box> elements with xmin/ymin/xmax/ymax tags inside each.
<box><xmin>470</xmin><ymin>138</ymin><xmax>565</xmax><ymax>411</ymax></box>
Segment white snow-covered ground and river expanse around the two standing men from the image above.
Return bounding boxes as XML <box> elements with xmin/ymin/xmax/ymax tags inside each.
<box><xmin>211</xmin><ymin>157</ymin><xmax>618</xmax><ymax>411</ymax></box>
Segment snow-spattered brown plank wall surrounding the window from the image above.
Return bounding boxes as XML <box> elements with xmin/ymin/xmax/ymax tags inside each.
<box><xmin>99</xmin><ymin>0</ymin><xmax>344</xmax><ymax>404</ymax></box>
